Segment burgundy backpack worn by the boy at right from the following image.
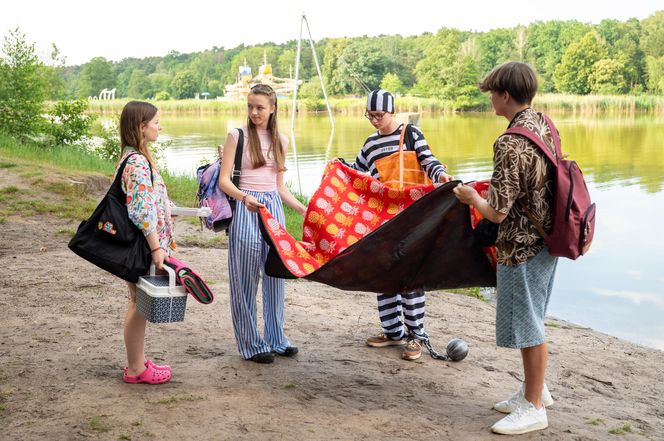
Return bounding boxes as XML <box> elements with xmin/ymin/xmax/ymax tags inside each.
<box><xmin>505</xmin><ymin>116</ymin><xmax>595</xmax><ymax>260</ymax></box>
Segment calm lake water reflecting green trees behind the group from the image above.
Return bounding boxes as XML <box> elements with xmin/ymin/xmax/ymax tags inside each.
<box><xmin>161</xmin><ymin>114</ymin><xmax>664</xmax><ymax>350</ymax></box>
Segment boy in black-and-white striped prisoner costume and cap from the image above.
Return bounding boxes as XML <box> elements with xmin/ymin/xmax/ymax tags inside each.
<box><xmin>350</xmin><ymin>89</ymin><xmax>452</xmax><ymax>360</ymax></box>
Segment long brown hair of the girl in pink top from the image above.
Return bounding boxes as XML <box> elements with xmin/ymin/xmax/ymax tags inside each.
<box><xmin>247</xmin><ymin>84</ymin><xmax>286</xmax><ymax>172</ymax></box>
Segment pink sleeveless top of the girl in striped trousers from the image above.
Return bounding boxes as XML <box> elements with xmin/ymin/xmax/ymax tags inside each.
<box><xmin>230</xmin><ymin>127</ymin><xmax>288</xmax><ymax>191</ymax></box>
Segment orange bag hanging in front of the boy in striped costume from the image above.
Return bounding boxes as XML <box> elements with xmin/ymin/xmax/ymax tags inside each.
<box><xmin>375</xmin><ymin>124</ymin><xmax>431</xmax><ymax>189</ymax></box>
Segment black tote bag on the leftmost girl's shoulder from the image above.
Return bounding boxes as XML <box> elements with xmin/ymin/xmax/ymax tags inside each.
<box><xmin>69</xmin><ymin>155</ymin><xmax>152</xmax><ymax>283</ymax></box>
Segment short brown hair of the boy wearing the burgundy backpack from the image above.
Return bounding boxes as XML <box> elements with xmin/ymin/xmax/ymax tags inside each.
<box><xmin>478</xmin><ymin>61</ymin><xmax>537</xmax><ymax>104</ymax></box>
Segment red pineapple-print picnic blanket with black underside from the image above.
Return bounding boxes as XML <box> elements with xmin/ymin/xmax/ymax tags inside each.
<box><xmin>259</xmin><ymin>160</ymin><xmax>496</xmax><ymax>293</ymax></box>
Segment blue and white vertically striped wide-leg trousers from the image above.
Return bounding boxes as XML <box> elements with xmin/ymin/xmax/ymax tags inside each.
<box><xmin>228</xmin><ymin>190</ymin><xmax>290</xmax><ymax>359</ymax></box>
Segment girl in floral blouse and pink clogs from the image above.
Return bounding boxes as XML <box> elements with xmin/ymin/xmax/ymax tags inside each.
<box><xmin>116</xmin><ymin>101</ymin><xmax>175</xmax><ymax>384</ymax></box>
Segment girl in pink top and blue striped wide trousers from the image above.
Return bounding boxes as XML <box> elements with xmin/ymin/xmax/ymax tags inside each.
<box><xmin>219</xmin><ymin>84</ymin><xmax>307</xmax><ymax>363</ymax></box>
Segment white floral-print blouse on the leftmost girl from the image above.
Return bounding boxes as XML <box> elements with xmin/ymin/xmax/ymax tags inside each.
<box><xmin>115</xmin><ymin>147</ymin><xmax>175</xmax><ymax>251</ymax></box>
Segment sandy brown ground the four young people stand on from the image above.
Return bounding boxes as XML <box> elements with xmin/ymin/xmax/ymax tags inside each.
<box><xmin>0</xmin><ymin>163</ymin><xmax>664</xmax><ymax>441</ymax></box>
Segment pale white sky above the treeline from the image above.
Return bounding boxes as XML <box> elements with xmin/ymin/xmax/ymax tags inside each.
<box><xmin>0</xmin><ymin>0</ymin><xmax>664</xmax><ymax>65</ymax></box>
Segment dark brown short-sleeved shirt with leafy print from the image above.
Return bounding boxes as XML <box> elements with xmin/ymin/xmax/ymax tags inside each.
<box><xmin>487</xmin><ymin>108</ymin><xmax>555</xmax><ymax>266</ymax></box>
